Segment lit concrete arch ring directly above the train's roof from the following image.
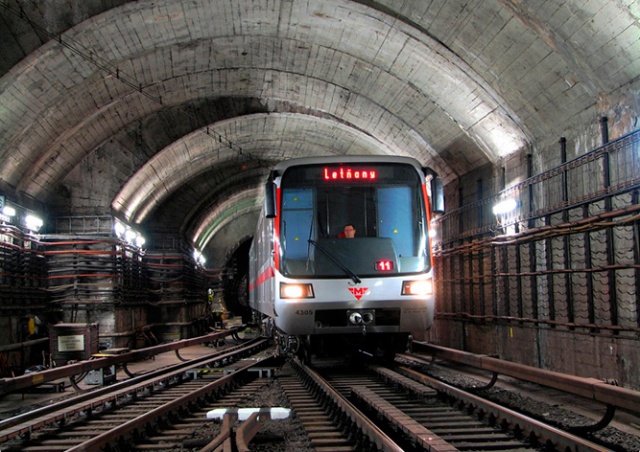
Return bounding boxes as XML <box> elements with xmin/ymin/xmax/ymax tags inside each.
<box><xmin>113</xmin><ymin>113</ymin><xmax>442</xmax><ymax>231</ymax></box>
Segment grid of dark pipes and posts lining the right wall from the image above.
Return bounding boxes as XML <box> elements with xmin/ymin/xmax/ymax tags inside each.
<box><xmin>435</xmin><ymin>131</ymin><xmax>640</xmax><ymax>335</ymax></box>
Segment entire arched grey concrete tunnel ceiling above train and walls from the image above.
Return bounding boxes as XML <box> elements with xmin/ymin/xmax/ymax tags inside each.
<box><xmin>0</xmin><ymin>0</ymin><xmax>640</xmax><ymax>265</ymax></box>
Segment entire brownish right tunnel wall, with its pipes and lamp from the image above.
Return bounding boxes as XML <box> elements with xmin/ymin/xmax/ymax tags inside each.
<box><xmin>428</xmin><ymin>121</ymin><xmax>640</xmax><ymax>389</ymax></box>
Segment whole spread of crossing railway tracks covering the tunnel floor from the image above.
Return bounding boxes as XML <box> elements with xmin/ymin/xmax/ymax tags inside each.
<box><xmin>0</xmin><ymin>340</ymin><xmax>632</xmax><ymax>452</ymax></box>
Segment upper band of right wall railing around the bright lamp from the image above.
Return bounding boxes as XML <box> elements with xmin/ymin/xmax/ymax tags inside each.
<box><xmin>437</xmin><ymin>131</ymin><xmax>640</xmax><ymax>248</ymax></box>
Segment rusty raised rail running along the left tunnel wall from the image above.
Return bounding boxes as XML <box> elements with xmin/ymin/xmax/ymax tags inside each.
<box><xmin>0</xmin><ymin>328</ymin><xmax>240</xmax><ymax>396</ymax></box>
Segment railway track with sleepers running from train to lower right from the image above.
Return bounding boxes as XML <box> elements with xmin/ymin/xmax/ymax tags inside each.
<box><xmin>302</xmin><ymin>356</ymin><xmax>608</xmax><ymax>451</ymax></box>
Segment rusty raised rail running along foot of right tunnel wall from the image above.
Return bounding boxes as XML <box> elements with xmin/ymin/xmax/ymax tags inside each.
<box><xmin>413</xmin><ymin>341</ymin><xmax>640</xmax><ymax>413</ymax></box>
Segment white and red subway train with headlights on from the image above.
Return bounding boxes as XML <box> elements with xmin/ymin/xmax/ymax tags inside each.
<box><xmin>248</xmin><ymin>156</ymin><xmax>444</xmax><ymax>360</ymax></box>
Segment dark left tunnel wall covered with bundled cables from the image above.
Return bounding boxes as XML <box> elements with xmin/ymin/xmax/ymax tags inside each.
<box><xmin>0</xmin><ymin>222</ymin><xmax>211</xmax><ymax>360</ymax></box>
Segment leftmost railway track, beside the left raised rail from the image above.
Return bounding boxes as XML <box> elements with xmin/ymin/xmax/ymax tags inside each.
<box><xmin>0</xmin><ymin>339</ymin><xmax>272</xmax><ymax>452</ymax></box>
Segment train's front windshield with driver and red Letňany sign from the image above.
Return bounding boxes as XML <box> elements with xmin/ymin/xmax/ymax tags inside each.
<box><xmin>280</xmin><ymin>163</ymin><xmax>431</xmax><ymax>278</ymax></box>
